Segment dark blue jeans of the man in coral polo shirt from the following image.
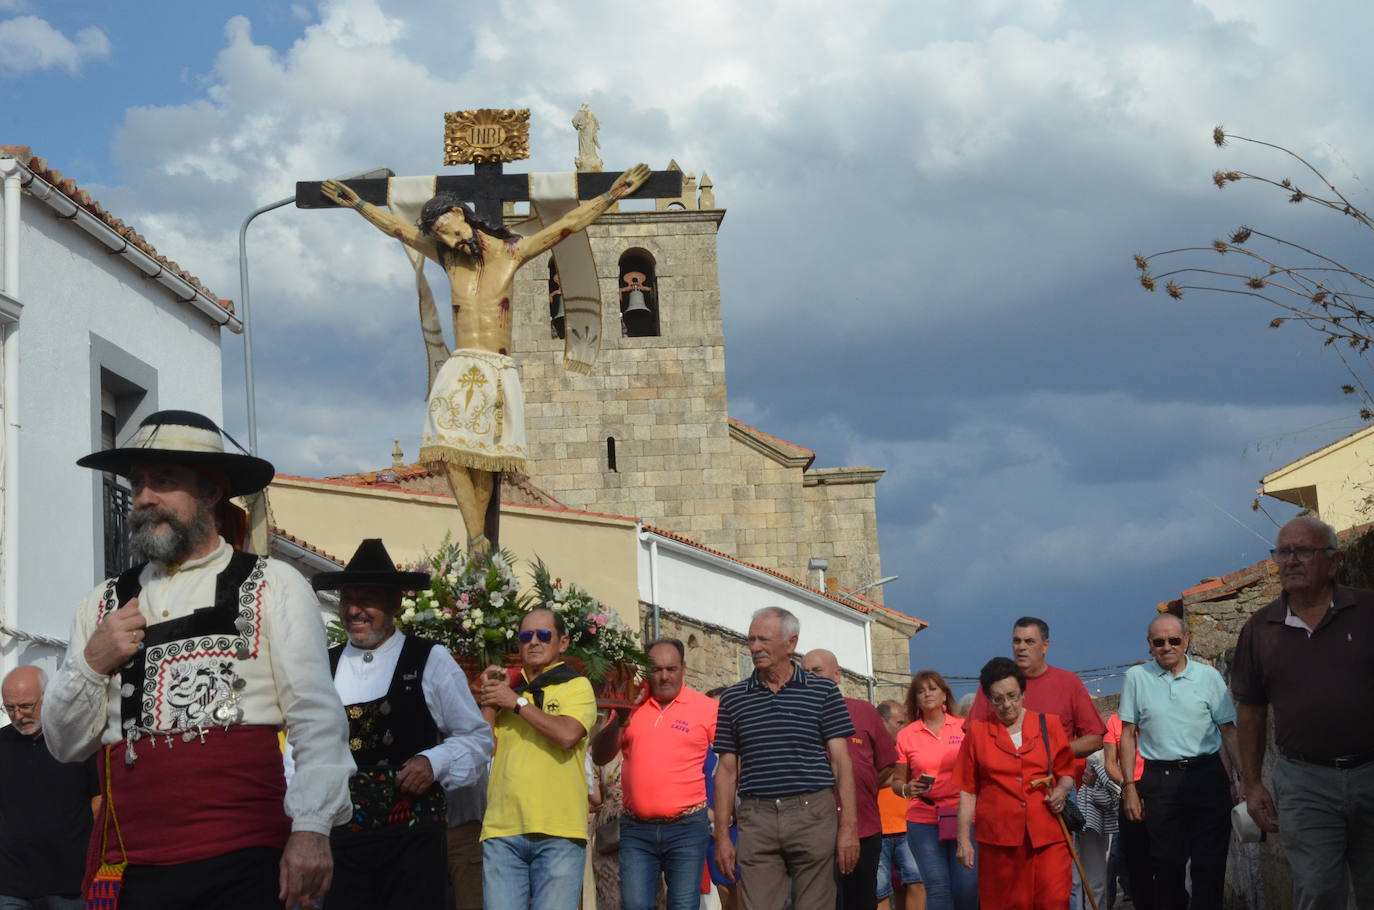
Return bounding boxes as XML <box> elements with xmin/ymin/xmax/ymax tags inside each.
<box><xmin>620</xmin><ymin>810</ymin><xmax>710</xmax><ymax>910</ymax></box>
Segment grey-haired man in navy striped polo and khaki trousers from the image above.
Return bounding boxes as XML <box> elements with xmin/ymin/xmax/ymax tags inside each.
<box><xmin>714</xmin><ymin>606</ymin><xmax>859</xmax><ymax>910</ymax></box>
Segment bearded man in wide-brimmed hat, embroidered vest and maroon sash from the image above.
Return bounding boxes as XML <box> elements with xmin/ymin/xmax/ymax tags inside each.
<box><xmin>45</xmin><ymin>411</ymin><xmax>354</xmax><ymax>910</ymax></box>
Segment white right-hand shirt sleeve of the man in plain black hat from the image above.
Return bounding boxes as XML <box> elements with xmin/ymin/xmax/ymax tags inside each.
<box><xmin>420</xmin><ymin>645</ymin><xmax>492</xmax><ymax>790</ymax></box>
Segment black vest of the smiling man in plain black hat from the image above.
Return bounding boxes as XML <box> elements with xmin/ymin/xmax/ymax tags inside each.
<box><xmin>330</xmin><ymin>635</ymin><xmax>448</xmax><ymax>836</ymax></box>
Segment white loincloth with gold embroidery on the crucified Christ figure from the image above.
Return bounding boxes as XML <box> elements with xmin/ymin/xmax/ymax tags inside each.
<box><xmin>419</xmin><ymin>348</ymin><xmax>525</xmax><ymax>473</ymax></box>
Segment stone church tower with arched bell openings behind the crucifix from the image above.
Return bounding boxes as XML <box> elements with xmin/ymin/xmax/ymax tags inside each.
<box><xmin>511</xmin><ymin>164</ymin><xmax>890</xmax><ymax>602</ymax></box>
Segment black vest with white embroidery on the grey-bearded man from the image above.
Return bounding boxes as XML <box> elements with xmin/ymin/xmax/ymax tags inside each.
<box><xmin>96</xmin><ymin>551</ymin><xmax>267</xmax><ymax>734</ymax></box>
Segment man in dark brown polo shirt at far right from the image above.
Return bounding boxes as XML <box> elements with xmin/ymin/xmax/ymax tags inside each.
<box><xmin>1231</xmin><ymin>517</ymin><xmax>1374</xmax><ymax>910</ymax></box>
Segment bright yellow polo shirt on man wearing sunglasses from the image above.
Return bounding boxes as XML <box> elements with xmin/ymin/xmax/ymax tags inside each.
<box><xmin>482</xmin><ymin>664</ymin><xmax>596</xmax><ymax>840</ymax></box>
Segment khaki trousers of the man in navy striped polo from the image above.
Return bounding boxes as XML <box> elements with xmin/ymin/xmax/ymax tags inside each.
<box><xmin>735</xmin><ymin>788</ymin><xmax>840</xmax><ymax>910</ymax></box>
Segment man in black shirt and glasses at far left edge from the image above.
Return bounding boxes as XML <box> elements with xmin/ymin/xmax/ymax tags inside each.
<box><xmin>0</xmin><ymin>667</ymin><xmax>100</xmax><ymax>910</ymax></box>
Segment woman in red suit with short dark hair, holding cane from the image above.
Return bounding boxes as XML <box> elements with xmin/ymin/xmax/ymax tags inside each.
<box><xmin>954</xmin><ymin>657</ymin><xmax>1073</xmax><ymax>910</ymax></box>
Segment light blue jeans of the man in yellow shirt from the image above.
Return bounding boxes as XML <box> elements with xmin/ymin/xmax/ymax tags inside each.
<box><xmin>482</xmin><ymin>834</ymin><xmax>587</xmax><ymax>910</ymax></box>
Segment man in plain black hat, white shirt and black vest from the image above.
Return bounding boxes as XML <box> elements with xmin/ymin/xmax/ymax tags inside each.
<box><xmin>311</xmin><ymin>539</ymin><xmax>492</xmax><ymax>910</ymax></box>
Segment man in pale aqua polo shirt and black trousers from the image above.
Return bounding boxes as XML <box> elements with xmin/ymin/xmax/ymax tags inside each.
<box><xmin>1118</xmin><ymin>613</ymin><xmax>1237</xmax><ymax>910</ymax></box>
